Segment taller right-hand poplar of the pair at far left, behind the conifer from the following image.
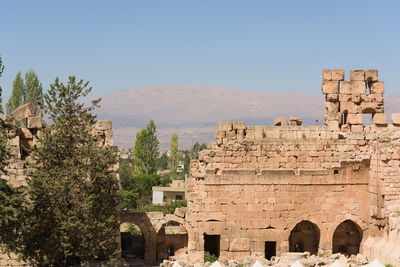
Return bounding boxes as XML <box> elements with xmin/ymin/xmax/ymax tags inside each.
<box><xmin>24</xmin><ymin>69</ymin><xmax>43</xmax><ymax>114</ymax></box>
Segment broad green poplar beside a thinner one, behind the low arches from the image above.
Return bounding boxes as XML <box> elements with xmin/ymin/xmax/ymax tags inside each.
<box><xmin>133</xmin><ymin>120</ymin><xmax>160</xmax><ymax>175</ymax></box>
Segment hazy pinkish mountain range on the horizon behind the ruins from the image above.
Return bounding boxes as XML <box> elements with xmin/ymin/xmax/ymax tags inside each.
<box><xmin>97</xmin><ymin>85</ymin><xmax>400</xmax><ymax>150</ymax></box>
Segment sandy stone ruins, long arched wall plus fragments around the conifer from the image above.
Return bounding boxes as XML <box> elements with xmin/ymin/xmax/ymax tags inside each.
<box><xmin>2</xmin><ymin>70</ymin><xmax>400</xmax><ymax>266</ymax></box>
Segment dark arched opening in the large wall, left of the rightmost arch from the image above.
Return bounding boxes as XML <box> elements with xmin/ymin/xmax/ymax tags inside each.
<box><xmin>289</xmin><ymin>221</ymin><xmax>320</xmax><ymax>254</ymax></box>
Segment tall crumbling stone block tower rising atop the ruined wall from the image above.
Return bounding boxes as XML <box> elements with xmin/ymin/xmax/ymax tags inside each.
<box><xmin>321</xmin><ymin>69</ymin><xmax>387</xmax><ymax>132</ymax></box>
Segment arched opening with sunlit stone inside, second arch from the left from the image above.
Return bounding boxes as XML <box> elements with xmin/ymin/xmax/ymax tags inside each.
<box><xmin>157</xmin><ymin>221</ymin><xmax>188</xmax><ymax>262</ymax></box>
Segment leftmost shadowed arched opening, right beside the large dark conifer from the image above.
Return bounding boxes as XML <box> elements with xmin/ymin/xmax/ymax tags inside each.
<box><xmin>120</xmin><ymin>223</ymin><xmax>145</xmax><ymax>263</ymax></box>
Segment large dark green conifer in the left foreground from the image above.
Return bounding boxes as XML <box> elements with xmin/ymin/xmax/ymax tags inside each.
<box><xmin>18</xmin><ymin>77</ymin><xmax>119</xmax><ymax>266</ymax></box>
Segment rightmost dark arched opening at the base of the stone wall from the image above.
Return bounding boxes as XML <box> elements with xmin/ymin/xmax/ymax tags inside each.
<box><xmin>332</xmin><ymin>220</ymin><xmax>362</xmax><ymax>256</ymax></box>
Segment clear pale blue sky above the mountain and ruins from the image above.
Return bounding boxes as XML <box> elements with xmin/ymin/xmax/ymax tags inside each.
<box><xmin>0</xmin><ymin>0</ymin><xmax>400</xmax><ymax>102</ymax></box>
